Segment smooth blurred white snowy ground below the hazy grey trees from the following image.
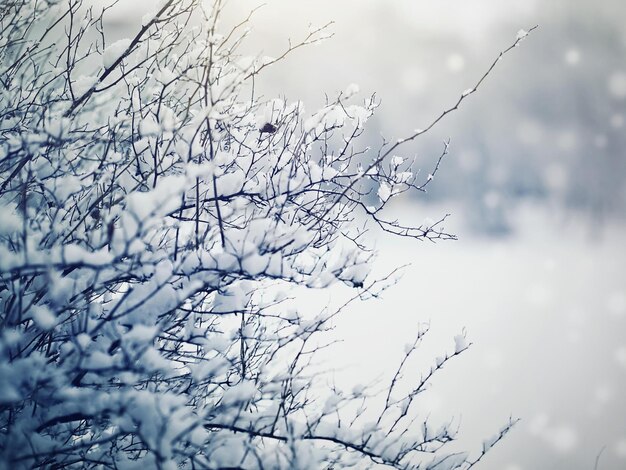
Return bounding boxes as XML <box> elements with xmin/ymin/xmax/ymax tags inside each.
<box><xmin>314</xmin><ymin>203</ymin><xmax>626</xmax><ymax>470</ymax></box>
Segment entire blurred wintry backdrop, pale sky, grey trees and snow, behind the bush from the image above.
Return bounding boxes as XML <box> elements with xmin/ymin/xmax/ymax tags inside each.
<box><xmin>98</xmin><ymin>0</ymin><xmax>626</xmax><ymax>470</ymax></box>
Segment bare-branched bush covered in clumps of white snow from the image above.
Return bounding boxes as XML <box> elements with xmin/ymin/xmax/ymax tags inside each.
<box><xmin>0</xmin><ymin>0</ymin><xmax>528</xmax><ymax>469</ymax></box>
